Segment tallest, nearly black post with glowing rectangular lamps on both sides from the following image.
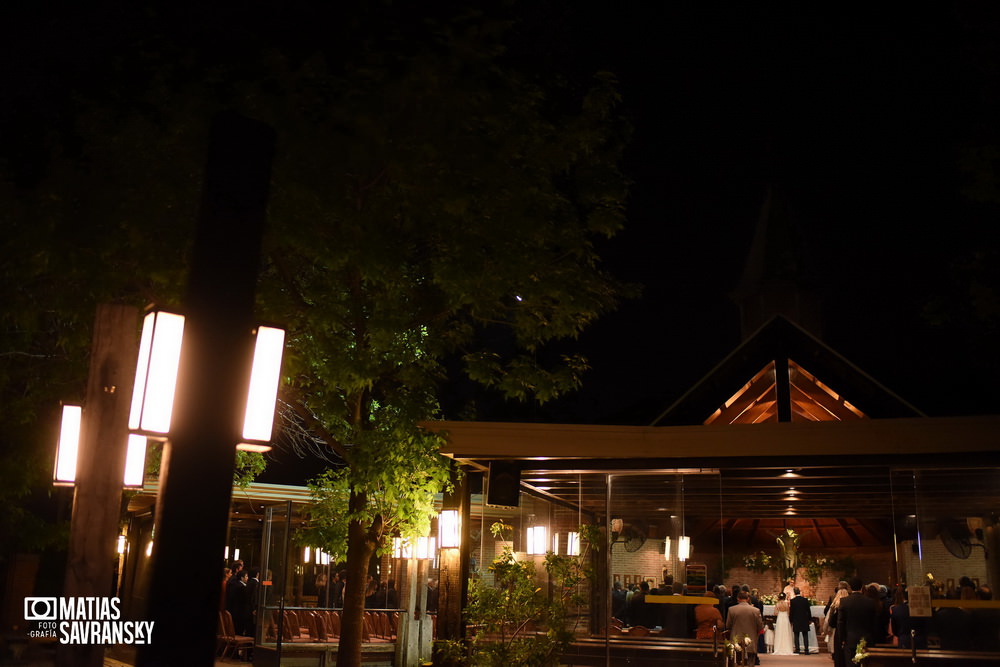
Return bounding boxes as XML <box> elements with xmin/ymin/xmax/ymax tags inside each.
<box><xmin>139</xmin><ymin>114</ymin><xmax>274</xmax><ymax>667</ymax></box>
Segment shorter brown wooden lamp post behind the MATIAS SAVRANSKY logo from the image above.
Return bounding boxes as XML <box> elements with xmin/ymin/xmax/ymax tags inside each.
<box><xmin>57</xmin><ymin>304</ymin><xmax>139</xmax><ymax>667</ymax></box>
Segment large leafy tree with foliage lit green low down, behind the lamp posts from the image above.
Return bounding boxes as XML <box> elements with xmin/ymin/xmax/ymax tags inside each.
<box><xmin>0</xmin><ymin>6</ymin><xmax>627</xmax><ymax>664</ymax></box>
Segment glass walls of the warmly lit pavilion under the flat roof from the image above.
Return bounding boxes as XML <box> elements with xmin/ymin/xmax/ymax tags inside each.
<box><xmin>238</xmin><ymin>466</ymin><xmax>1000</xmax><ymax>663</ymax></box>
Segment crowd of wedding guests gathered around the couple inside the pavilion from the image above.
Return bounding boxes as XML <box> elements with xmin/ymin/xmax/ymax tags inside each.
<box><xmin>611</xmin><ymin>577</ymin><xmax>1000</xmax><ymax>667</ymax></box>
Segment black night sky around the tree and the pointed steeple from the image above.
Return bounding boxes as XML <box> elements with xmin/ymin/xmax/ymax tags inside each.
<box><xmin>7</xmin><ymin>2</ymin><xmax>1000</xmax><ymax>424</ymax></box>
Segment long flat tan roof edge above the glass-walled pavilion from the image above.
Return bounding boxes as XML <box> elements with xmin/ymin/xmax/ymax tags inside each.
<box><xmin>422</xmin><ymin>416</ymin><xmax>1000</xmax><ymax>467</ymax></box>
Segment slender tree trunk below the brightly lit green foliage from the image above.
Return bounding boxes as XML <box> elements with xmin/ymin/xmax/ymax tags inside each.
<box><xmin>337</xmin><ymin>491</ymin><xmax>375</xmax><ymax>667</ymax></box>
